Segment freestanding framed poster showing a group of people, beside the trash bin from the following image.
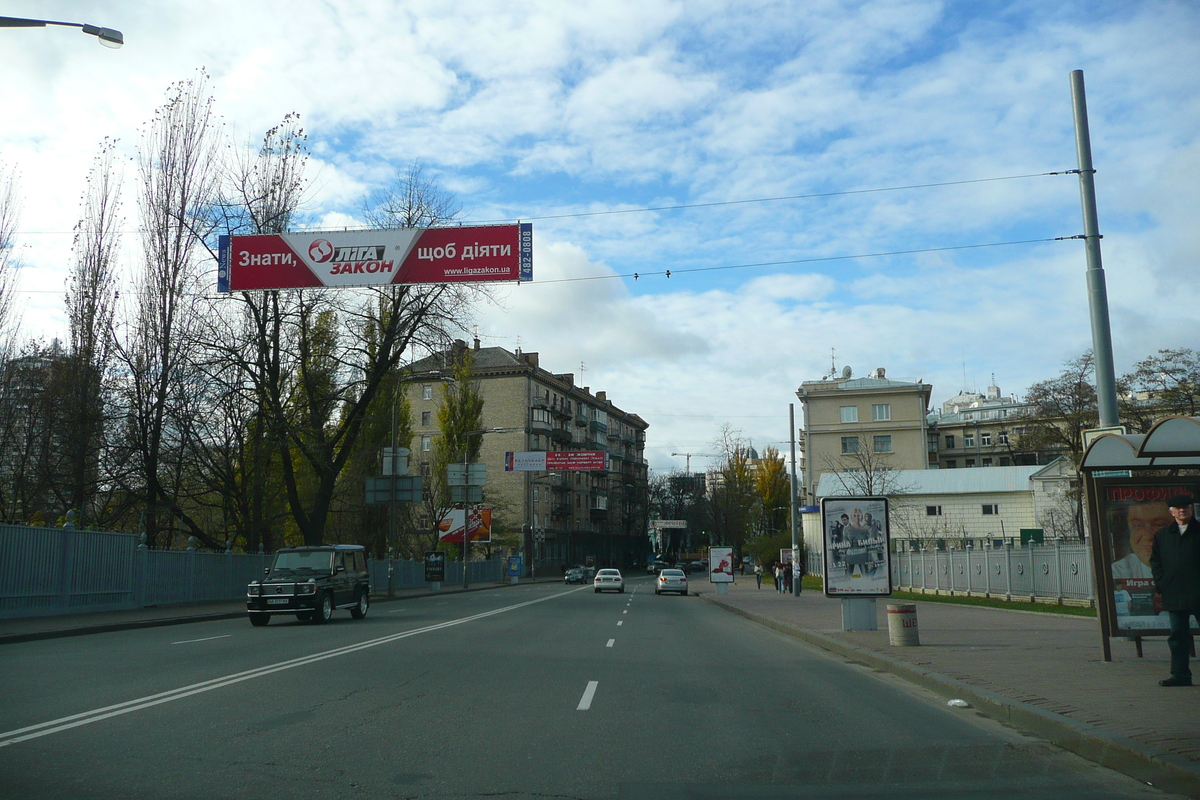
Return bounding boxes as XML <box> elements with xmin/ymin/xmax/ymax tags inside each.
<box><xmin>821</xmin><ymin>498</ymin><xmax>892</xmax><ymax>597</ymax></box>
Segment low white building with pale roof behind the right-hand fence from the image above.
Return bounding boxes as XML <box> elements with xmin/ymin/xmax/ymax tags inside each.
<box><xmin>804</xmin><ymin>459</ymin><xmax>1070</xmax><ymax>552</ymax></box>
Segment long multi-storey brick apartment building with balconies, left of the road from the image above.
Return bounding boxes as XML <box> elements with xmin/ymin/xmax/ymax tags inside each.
<box><xmin>406</xmin><ymin>339</ymin><xmax>649</xmax><ymax>567</ymax></box>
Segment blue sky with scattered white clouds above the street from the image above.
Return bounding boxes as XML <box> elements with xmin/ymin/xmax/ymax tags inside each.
<box><xmin>0</xmin><ymin>0</ymin><xmax>1200</xmax><ymax>469</ymax></box>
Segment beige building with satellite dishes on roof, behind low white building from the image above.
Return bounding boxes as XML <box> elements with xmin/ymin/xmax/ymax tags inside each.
<box><xmin>796</xmin><ymin>367</ymin><xmax>934</xmax><ymax>504</ymax></box>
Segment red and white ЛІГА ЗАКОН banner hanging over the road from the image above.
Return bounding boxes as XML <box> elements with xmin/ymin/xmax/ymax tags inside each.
<box><xmin>217</xmin><ymin>223</ymin><xmax>533</xmax><ymax>291</ymax></box>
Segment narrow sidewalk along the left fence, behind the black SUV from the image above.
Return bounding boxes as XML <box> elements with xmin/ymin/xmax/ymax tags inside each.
<box><xmin>0</xmin><ymin>577</ymin><xmax>552</xmax><ymax>645</ymax></box>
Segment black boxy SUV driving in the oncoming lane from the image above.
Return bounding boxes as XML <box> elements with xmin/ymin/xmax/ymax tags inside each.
<box><xmin>246</xmin><ymin>545</ymin><xmax>371</xmax><ymax>626</ymax></box>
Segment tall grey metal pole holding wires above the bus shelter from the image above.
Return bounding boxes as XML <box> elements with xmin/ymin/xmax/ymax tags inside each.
<box><xmin>1070</xmin><ymin>70</ymin><xmax>1120</xmax><ymax>428</ymax></box>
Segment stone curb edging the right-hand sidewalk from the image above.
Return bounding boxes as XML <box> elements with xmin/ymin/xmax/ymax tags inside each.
<box><xmin>698</xmin><ymin>594</ymin><xmax>1200</xmax><ymax>800</ymax></box>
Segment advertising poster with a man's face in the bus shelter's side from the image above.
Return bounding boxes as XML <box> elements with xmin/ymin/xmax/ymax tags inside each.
<box><xmin>1097</xmin><ymin>479</ymin><xmax>1200</xmax><ymax>633</ymax></box>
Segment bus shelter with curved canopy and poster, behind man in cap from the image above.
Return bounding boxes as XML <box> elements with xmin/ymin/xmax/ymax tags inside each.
<box><xmin>1080</xmin><ymin>416</ymin><xmax>1200</xmax><ymax>661</ymax></box>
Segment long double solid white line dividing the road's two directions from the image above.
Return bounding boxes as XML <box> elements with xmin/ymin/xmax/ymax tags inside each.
<box><xmin>0</xmin><ymin>590</ymin><xmax>577</xmax><ymax>747</ymax></box>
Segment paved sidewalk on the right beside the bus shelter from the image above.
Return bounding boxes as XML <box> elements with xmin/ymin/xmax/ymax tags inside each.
<box><xmin>696</xmin><ymin>581</ymin><xmax>1200</xmax><ymax>798</ymax></box>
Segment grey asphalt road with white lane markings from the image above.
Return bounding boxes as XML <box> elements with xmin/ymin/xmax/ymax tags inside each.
<box><xmin>0</xmin><ymin>577</ymin><xmax>1180</xmax><ymax>800</ymax></box>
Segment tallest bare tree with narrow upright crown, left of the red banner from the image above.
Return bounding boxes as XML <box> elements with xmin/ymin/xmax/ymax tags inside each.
<box><xmin>116</xmin><ymin>71</ymin><xmax>218</xmax><ymax>547</ymax></box>
